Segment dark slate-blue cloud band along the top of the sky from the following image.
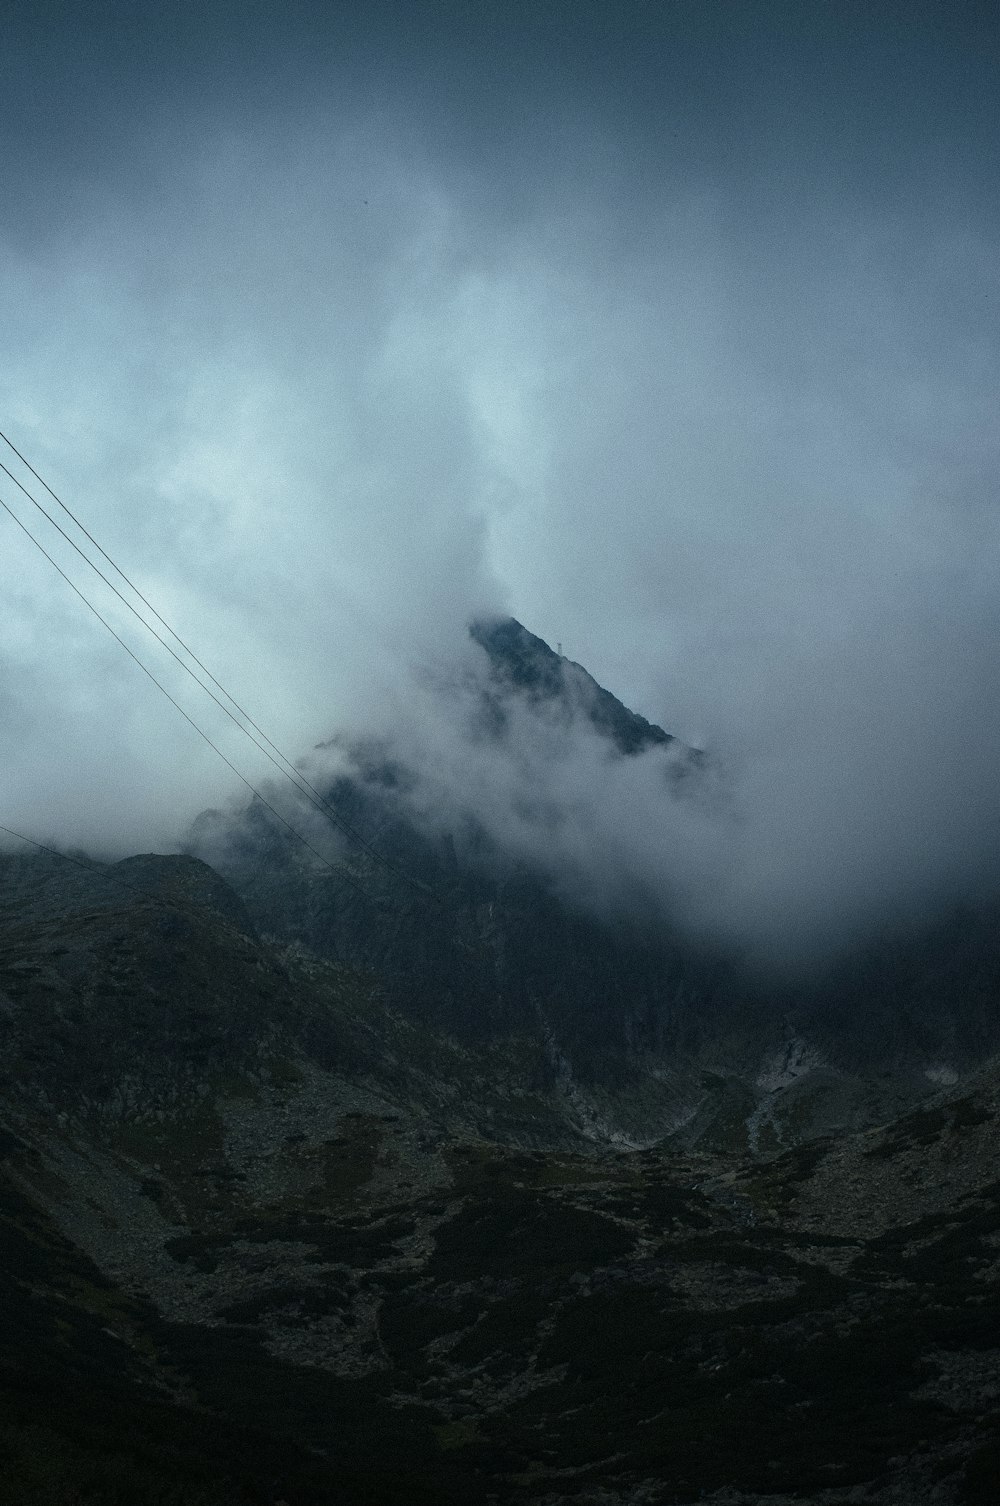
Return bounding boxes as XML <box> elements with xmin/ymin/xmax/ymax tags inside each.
<box><xmin>9</xmin><ymin>0</ymin><xmax>997</xmax><ymax>225</ymax></box>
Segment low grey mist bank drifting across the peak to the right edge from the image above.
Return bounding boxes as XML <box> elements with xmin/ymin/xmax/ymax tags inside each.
<box><xmin>312</xmin><ymin>575</ymin><xmax>1000</xmax><ymax>965</ymax></box>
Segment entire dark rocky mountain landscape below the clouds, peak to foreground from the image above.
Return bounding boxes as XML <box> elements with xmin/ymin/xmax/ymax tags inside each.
<box><xmin>0</xmin><ymin>623</ymin><xmax>1000</xmax><ymax>1506</ymax></box>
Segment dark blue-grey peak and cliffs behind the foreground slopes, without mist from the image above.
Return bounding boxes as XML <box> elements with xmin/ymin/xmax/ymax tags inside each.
<box><xmin>191</xmin><ymin>619</ymin><xmax>1000</xmax><ymax>1151</ymax></box>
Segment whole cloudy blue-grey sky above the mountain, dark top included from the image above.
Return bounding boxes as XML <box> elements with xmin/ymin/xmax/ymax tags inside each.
<box><xmin>0</xmin><ymin>0</ymin><xmax>1000</xmax><ymax>937</ymax></box>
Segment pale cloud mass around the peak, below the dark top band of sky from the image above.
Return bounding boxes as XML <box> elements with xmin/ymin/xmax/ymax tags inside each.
<box><xmin>0</xmin><ymin>113</ymin><xmax>1000</xmax><ymax>935</ymax></box>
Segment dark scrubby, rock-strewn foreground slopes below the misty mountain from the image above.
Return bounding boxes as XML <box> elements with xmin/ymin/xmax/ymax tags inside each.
<box><xmin>0</xmin><ymin>857</ymin><xmax>1000</xmax><ymax>1506</ymax></box>
